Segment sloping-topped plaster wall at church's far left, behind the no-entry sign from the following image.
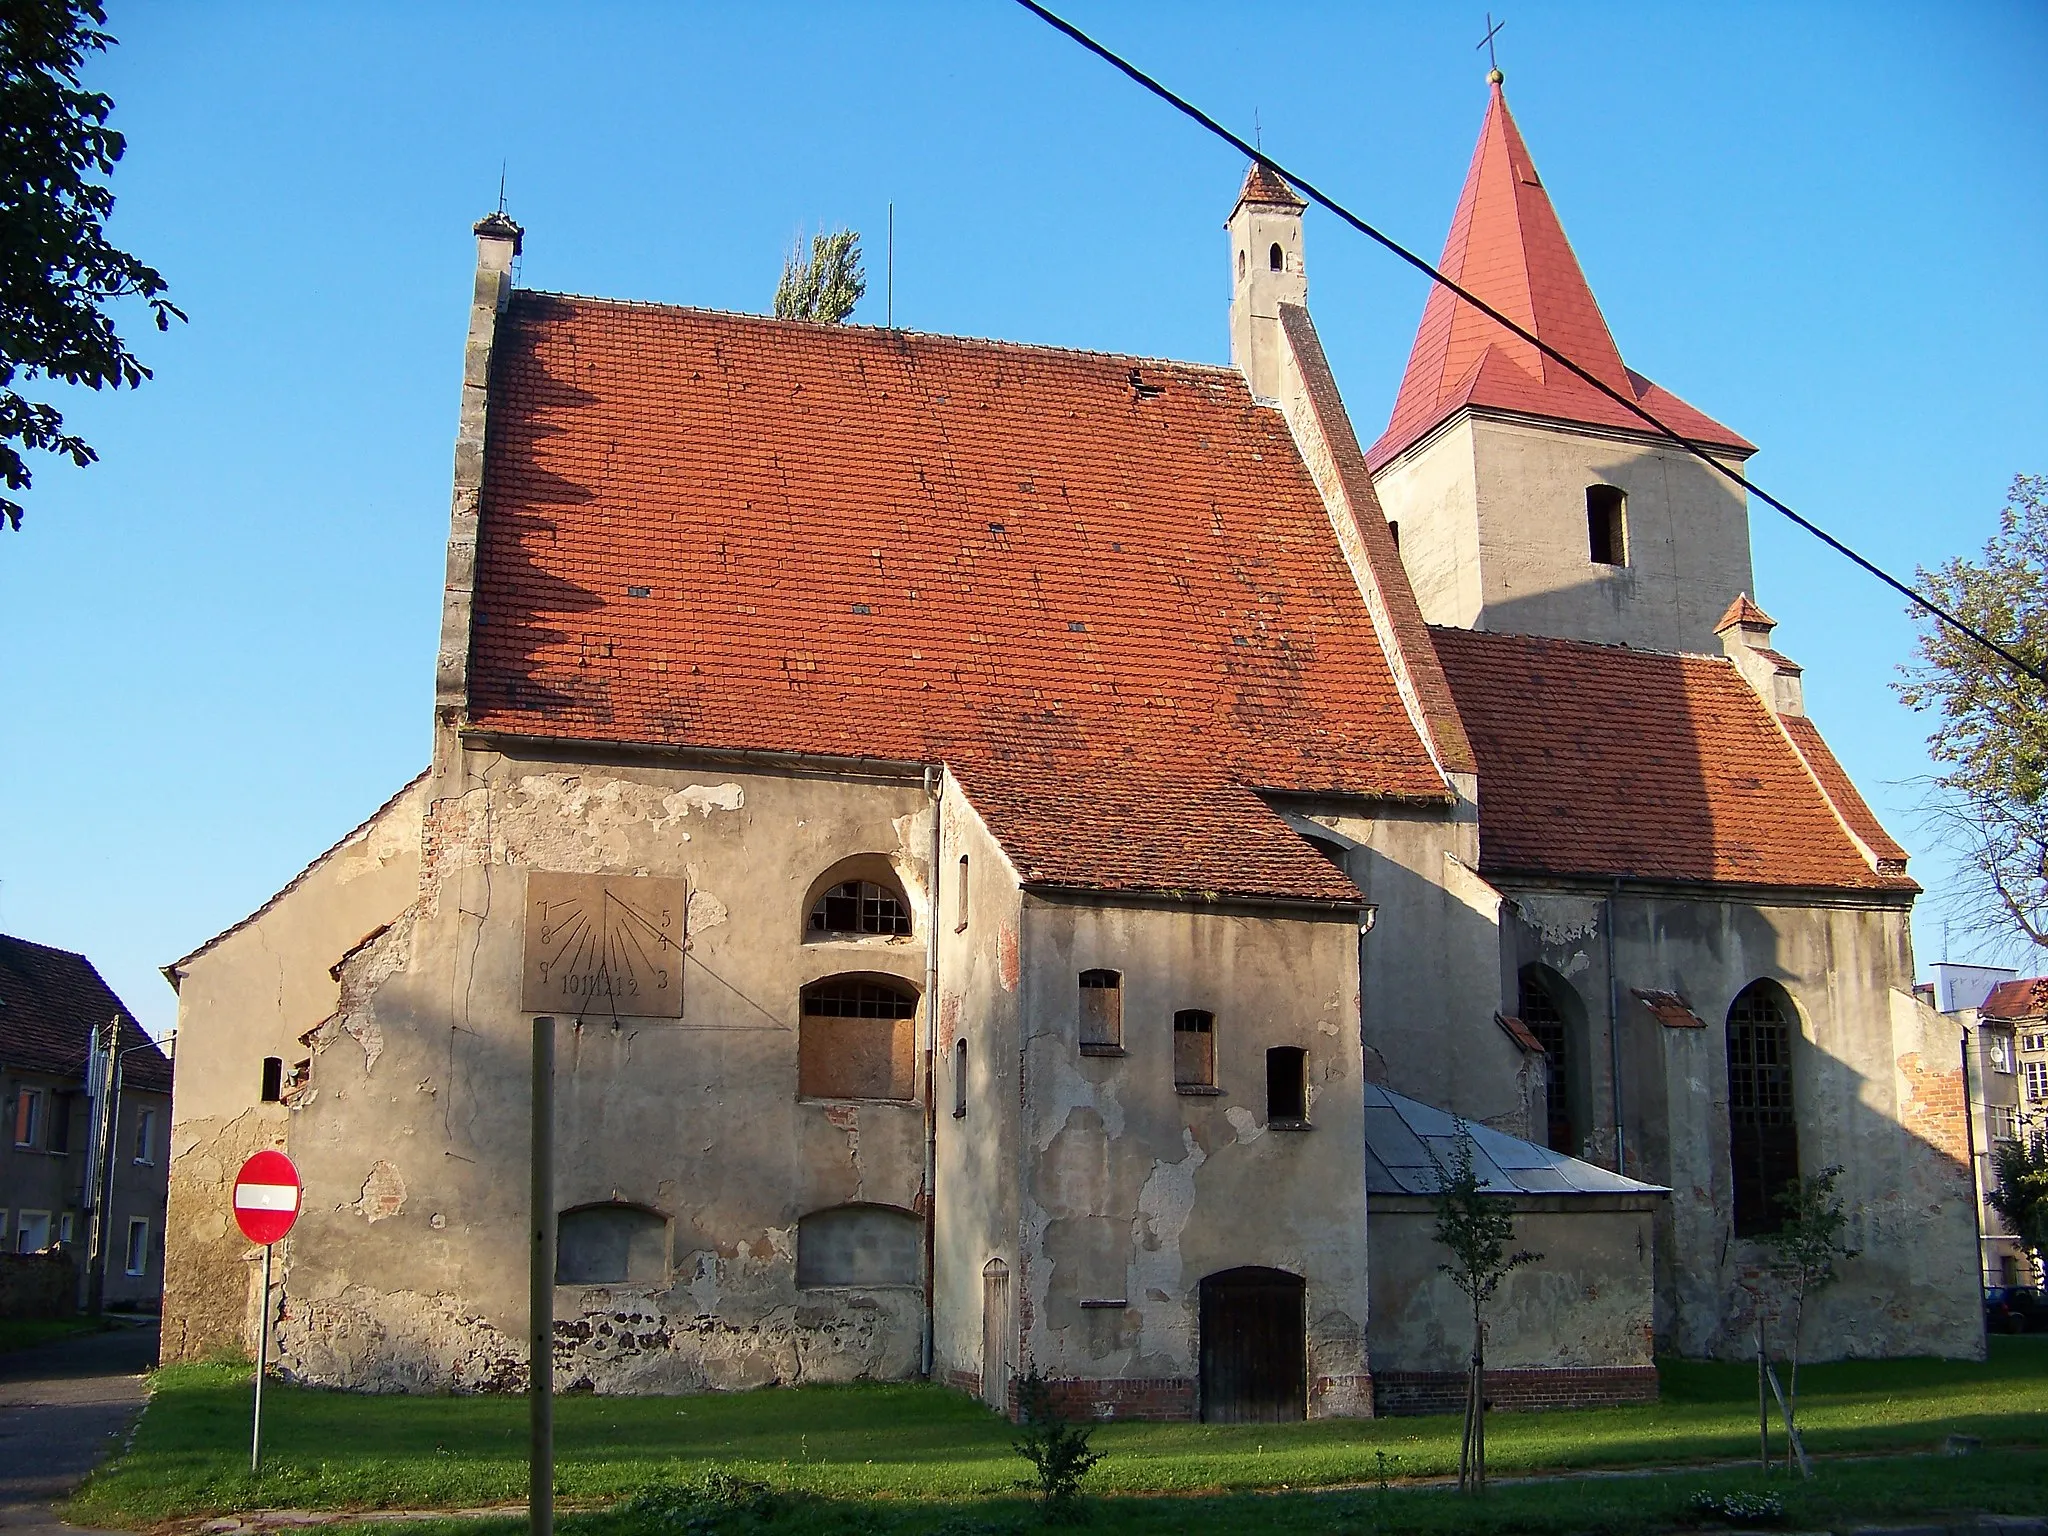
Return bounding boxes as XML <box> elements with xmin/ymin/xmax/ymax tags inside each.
<box><xmin>164</xmin><ymin>782</ymin><xmax>426</xmax><ymax>1360</ymax></box>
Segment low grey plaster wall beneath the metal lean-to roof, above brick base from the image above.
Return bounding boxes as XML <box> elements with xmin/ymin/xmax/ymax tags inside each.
<box><xmin>1372</xmin><ymin>1196</ymin><xmax>1661</xmax><ymax>1372</ymax></box>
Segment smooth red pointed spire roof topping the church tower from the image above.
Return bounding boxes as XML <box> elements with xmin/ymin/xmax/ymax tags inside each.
<box><xmin>1366</xmin><ymin>84</ymin><xmax>1755</xmax><ymax>469</ymax></box>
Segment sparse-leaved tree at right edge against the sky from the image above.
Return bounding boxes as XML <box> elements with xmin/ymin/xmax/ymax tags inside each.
<box><xmin>1898</xmin><ymin>475</ymin><xmax>2048</xmax><ymax>948</ymax></box>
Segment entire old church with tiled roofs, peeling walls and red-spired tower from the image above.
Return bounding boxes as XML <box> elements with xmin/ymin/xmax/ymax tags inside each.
<box><xmin>164</xmin><ymin>72</ymin><xmax>1982</xmax><ymax>1419</ymax></box>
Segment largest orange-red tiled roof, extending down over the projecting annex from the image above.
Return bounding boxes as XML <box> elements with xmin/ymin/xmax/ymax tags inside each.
<box><xmin>469</xmin><ymin>293</ymin><xmax>1448</xmax><ymax>901</ymax></box>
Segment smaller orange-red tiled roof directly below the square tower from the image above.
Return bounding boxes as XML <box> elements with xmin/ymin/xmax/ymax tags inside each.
<box><xmin>1430</xmin><ymin>629</ymin><xmax>1919</xmax><ymax>893</ymax></box>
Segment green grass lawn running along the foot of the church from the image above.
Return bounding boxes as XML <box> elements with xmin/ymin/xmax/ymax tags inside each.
<box><xmin>70</xmin><ymin>1337</ymin><xmax>2048</xmax><ymax>1536</ymax></box>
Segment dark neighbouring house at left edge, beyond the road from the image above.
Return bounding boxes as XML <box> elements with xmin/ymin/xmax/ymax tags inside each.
<box><xmin>0</xmin><ymin>934</ymin><xmax>170</xmax><ymax>1309</ymax></box>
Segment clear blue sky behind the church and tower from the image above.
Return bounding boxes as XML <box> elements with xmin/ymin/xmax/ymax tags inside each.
<box><xmin>0</xmin><ymin>0</ymin><xmax>2048</xmax><ymax>1030</ymax></box>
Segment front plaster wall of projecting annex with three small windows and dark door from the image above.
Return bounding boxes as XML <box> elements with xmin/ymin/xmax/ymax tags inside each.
<box><xmin>1020</xmin><ymin>897</ymin><xmax>1370</xmax><ymax>1417</ymax></box>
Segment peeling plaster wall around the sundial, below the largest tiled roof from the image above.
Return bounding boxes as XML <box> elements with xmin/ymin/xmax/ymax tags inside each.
<box><xmin>279</xmin><ymin>752</ymin><xmax>932</xmax><ymax>1393</ymax></box>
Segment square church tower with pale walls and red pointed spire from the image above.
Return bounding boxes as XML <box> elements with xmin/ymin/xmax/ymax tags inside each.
<box><xmin>1359</xmin><ymin>70</ymin><xmax>1755</xmax><ymax>653</ymax></box>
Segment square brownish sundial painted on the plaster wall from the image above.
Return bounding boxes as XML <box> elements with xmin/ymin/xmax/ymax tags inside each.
<box><xmin>520</xmin><ymin>872</ymin><xmax>688</xmax><ymax>1018</ymax></box>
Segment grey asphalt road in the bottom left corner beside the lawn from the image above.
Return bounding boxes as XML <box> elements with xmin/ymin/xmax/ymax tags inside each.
<box><xmin>0</xmin><ymin>1323</ymin><xmax>158</xmax><ymax>1536</ymax></box>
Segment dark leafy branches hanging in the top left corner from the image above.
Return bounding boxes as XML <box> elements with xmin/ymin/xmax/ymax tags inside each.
<box><xmin>0</xmin><ymin>0</ymin><xmax>184</xmax><ymax>528</ymax></box>
